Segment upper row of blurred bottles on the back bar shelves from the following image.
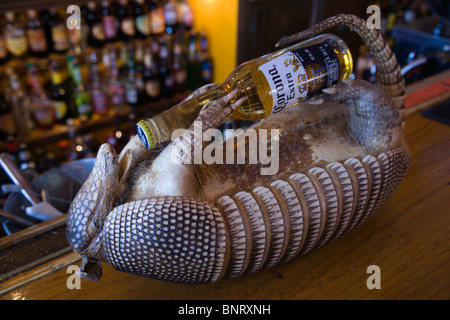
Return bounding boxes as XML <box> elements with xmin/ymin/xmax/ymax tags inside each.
<box><xmin>0</xmin><ymin>0</ymin><xmax>193</xmax><ymax>65</ymax></box>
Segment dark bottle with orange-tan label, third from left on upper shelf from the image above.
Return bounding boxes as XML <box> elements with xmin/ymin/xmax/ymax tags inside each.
<box><xmin>47</xmin><ymin>7</ymin><xmax>70</xmax><ymax>53</ymax></box>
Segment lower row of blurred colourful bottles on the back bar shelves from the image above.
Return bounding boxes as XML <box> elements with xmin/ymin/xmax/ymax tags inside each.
<box><xmin>0</xmin><ymin>23</ymin><xmax>212</xmax><ymax>140</ymax></box>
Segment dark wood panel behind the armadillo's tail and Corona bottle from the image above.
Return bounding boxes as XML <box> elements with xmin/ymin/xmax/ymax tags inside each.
<box><xmin>237</xmin><ymin>0</ymin><xmax>370</xmax><ymax>64</ymax></box>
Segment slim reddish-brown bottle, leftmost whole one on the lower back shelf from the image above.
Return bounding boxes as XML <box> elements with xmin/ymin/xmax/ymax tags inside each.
<box><xmin>6</xmin><ymin>68</ymin><xmax>34</xmax><ymax>136</ymax></box>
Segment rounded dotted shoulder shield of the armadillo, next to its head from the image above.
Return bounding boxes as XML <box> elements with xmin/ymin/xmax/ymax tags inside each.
<box><xmin>102</xmin><ymin>197</ymin><xmax>229</xmax><ymax>283</ymax></box>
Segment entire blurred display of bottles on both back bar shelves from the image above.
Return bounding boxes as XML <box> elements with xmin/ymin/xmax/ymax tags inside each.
<box><xmin>0</xmin><ymin>0</ymin><xmax>213</xmax><ymax>168</ymax></box>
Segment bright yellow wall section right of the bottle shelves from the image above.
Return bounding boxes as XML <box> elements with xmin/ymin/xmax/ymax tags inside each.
<box><xmin>188</xmin><ymin>0</ymin><xmax>239</xmax><ymax>82</ymax></box>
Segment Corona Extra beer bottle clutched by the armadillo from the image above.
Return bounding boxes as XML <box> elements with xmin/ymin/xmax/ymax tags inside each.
<box><xmin>137</xmin><ymin>34</ymin><xmax>353</xmax><ymax>148</ymax></box>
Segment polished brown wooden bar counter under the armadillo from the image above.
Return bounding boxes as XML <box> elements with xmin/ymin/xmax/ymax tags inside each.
<box><xmin>0</xmin><ymin>72</ymin><xmax>450</xmax><ymax>300</ymax></box>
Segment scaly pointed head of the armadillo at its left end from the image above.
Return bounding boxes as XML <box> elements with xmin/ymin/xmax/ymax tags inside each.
<box><xmin>66</xmin><ymin>143</ymin><xmax>124</xmax><ymax>280</ymax></box>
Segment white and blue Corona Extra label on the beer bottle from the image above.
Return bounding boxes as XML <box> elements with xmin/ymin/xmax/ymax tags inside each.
<box><xmin>259</xmin><ymin>43</ymin><xmax>339</xmax><ymax>113</ymax></box>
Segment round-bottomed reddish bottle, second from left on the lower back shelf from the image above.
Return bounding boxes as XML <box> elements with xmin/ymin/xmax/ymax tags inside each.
<box><xmin>27</xmin><ymin>62</ymin><xmax>55</xmax><ymax>130</ymax></box>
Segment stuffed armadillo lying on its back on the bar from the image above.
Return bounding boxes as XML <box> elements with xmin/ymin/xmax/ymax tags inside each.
<box><xmin>66</xmin><ymin>15</ymin><xmax>410</xmax><ymax>283</ymax></box>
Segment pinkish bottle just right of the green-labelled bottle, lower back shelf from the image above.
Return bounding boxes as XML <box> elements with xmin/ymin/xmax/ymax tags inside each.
<box><xmin>89</xmin><ymin>52</ymin><xmax>110</xmax><ymax>115</ymax></box>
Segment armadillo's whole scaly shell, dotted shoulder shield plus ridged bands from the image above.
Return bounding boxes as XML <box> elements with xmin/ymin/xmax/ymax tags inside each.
<box><xmin>85</xmin><ymin>149</ymin><xmax>410</xmax><ymax>283</ymax></box>
